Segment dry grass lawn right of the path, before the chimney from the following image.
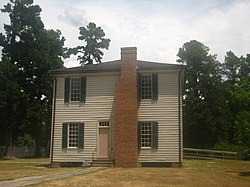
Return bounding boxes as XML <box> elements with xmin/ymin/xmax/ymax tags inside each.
<box><xmin>36</xmin><ymin>160</ymin><xmax>250</xmax><ymax>187</ymax></box>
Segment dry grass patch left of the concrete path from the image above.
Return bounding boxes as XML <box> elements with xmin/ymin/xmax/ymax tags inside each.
<box><xmin>0</xmin><ymin>158</ymin><xmax>80</xmax><ymax>181</ymax></box>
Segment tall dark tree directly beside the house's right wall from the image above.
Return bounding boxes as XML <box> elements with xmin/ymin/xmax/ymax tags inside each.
<box><xmin>177</xmin><ymin>40</ymin><xmax>230</xmax><ymax>147</ymax></box>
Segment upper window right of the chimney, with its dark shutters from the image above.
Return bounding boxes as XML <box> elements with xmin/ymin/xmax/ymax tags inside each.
<box><xmin>137</xmin><ymin>74</ymin><xmax>158</xmax><ymax>101</ymax></box>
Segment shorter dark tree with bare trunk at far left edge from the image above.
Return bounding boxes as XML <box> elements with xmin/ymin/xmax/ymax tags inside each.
<box><xmin>0</xmin><ymin>61</ymin><xmax>25</xmax><ymax>157</ymax></box>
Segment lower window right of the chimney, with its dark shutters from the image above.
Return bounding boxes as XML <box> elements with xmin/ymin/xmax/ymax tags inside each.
<box><xmin>138</xmin><ymin>121</ymin><xmax>158</xmax><ymax>149</ymax></box>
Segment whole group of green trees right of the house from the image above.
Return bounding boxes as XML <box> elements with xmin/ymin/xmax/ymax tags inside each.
<box><xmin>177</xmin><ymin>40</ymin><xmax>250</xmax><ymax>158</ymax></box>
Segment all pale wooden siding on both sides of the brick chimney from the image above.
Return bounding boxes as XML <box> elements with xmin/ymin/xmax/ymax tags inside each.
<box><xmin>53</xmin><ymin>71</ymin><xmax>182</xmax><ymax>162</ymax></box>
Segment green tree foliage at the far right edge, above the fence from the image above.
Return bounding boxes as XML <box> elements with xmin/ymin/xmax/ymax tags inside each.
<box><xmin>223</xmin><ymin>51</ymin><xmax>250</xmax><ymax>148</ymax></box>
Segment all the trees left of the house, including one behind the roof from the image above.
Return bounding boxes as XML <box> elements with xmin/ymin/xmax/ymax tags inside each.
<box><xmin>0</xmin><ymin>0</ymin><xmax>110</xmax><ymax>157</ymax></box>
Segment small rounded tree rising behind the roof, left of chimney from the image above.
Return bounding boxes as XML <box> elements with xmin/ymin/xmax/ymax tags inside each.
<box><xmin>68</xmin><ymin>22</ymin><xmax>110</xmax><ymax>65</ymax></box>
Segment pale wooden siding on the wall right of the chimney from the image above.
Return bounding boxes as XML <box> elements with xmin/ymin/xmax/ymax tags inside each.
<box><xmin>138</xmin><ymin>71</ymin><xmax>182</xmax><ymax>162</ymax></box>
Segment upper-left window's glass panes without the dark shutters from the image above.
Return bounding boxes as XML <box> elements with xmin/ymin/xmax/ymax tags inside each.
<box><xmin>70</xmin><ymin>78</ymin><xmax>81</xmax><ymax>101</ymax></box>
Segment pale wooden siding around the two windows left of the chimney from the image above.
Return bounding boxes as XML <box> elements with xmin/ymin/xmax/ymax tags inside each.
<box><xmin>53</xmin><ymin>74</ymin><xmax>120</xmax><ymax>162</ymax></box>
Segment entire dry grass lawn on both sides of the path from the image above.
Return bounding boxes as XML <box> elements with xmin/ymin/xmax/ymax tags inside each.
<box><xmin>0</xmin><ymin>159</ymin><xmax>250</xmax><ymax>187</ymax></box>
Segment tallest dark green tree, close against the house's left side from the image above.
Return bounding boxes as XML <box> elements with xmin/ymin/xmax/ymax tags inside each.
<box><xmin>0</xmin><ymin>0</ymin><xmax>65</xmax><ymax>156</ymax></box>
